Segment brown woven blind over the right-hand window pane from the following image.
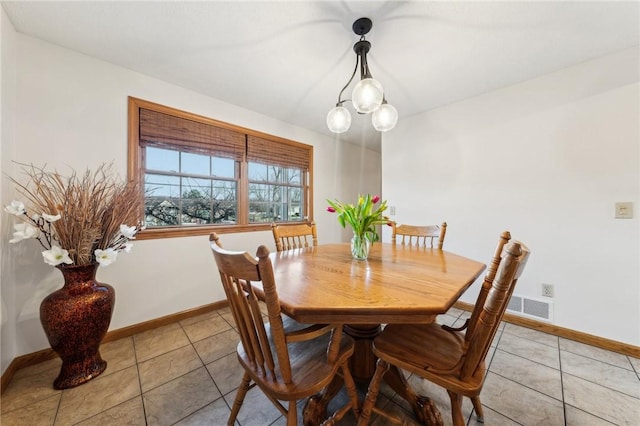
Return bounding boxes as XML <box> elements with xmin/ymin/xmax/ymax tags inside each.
<box><xmin>247</xmin><ymin>135</ymin><xmax>311</xmax><ymax>171</ymax></box>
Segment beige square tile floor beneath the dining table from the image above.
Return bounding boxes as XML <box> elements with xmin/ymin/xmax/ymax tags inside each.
<box><xmin>0</xmin><ymin>309</ymin><xmax>640</xmax><ymax>426</ymax></box>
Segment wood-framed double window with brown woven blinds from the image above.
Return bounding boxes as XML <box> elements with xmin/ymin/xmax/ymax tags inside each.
<box><xmin>129</xmin><ymin>98</ymin><xmax>313</xmax><ymax>239</ymax></box>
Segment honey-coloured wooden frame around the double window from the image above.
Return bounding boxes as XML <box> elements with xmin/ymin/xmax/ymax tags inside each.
<box><xmin>127</xmin><ymin>96</ymin><xmax>313</xmax><ymax>240</ymax></box>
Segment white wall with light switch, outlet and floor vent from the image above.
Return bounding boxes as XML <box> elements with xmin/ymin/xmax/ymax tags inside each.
<box><xmin>382</xmin><ymin>48</ymin><xmax>640</xmax><ymax>346</ymax></box>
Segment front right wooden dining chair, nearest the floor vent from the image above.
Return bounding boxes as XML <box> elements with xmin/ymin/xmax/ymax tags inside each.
<box><xmin>358</xmin><ymin>233</ymin><xmax>529</xmax><ymax>426</ymax></box>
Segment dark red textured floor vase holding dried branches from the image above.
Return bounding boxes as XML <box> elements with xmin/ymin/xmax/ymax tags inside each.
<box><xmin>40</xmin><ymin>263</ymin><xmax>115</xmax><ymax>389</ymax></box>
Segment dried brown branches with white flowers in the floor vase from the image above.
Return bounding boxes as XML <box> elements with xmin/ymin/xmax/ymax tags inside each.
<box><xmin>5</xmin><ymin>163</ymin><xmax>144</xmax><ymax>266</ymax></box>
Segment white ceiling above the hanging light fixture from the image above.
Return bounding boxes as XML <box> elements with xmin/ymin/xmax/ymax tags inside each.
<box><xmin>2</xmin><ymin>1</ymin><xmax>640</xmax><ymax>150</ymax></box>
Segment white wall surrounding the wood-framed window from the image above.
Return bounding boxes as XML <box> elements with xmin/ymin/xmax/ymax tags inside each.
<box><xmin>1</xmin><ymin>27</ymin><xmax>380</xmax><ymax>371</ymax></box>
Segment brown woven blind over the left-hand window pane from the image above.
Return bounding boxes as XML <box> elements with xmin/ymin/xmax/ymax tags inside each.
<box><xmin>140</xmin><ymin>108</ymin><xmax>245</xmax><ymax>161</ymax></box>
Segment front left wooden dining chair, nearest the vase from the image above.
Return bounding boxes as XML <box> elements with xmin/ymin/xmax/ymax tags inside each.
<box><xmin>209</xmin><ymin>233</ymin><xmax>359</xmax><ymax>426</ymax></box>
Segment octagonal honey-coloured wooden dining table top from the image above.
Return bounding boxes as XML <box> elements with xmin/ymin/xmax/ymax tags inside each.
<box><xmin>256</xmin><ymin>243</ymin><xmax>486</xmax><ymax>324</ymax></box>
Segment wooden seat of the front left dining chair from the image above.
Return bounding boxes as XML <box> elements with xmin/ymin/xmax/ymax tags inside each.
<box><xmin>237</xmin><ymin>324</ymin><xmax>354</xmax><ymax>401</ymax></box>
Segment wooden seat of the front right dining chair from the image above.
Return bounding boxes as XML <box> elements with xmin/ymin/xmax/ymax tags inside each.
<box><xmin>373</xmin><ymin>323</ymin><xmax>485</xmax><ymax>397</ymax></box>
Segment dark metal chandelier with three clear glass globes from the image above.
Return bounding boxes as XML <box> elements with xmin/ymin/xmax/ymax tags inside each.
<box><xmin>327</xmin><ymin>18</ymin><xmax>398</xmax><ymax>133</ymax></box>
